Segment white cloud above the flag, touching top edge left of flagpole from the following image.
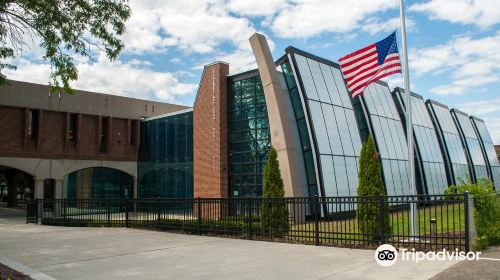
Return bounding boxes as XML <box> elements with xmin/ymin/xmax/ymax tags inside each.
<box><xmin>270</xmin><ymin>0</ymin><xmax>397</xmax><ymax>38</ymax></box>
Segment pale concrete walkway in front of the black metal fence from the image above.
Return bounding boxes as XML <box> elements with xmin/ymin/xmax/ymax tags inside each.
<box><xmin>0</xmin><ymin>212</ymin><xmax>455</xmax><ymax>280</ymax></box>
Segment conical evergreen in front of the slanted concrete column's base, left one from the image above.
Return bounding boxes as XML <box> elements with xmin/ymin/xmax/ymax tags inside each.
<box><xmin>261</xmin><ymin>147</ymin><xmax>290</xmax><ymax>234</ymax></box>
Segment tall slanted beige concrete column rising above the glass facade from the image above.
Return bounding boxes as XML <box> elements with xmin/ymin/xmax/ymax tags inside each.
<box><xmin>249</xmin><ymin>33</ymin><xmax>305</xmax><ymax>197</ymax></box>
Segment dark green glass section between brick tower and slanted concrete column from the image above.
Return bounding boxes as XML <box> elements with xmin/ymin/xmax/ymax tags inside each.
<box><xmin>228</xmin><ymin>74</ymin><xmax>271</xmax><ymax>197</ymax></box>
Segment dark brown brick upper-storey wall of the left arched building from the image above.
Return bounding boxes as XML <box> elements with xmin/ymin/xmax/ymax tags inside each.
<box><xmin>0</xmin><ymin>106</ymin><xmax>140</xmax><ymax>161</ymax></box>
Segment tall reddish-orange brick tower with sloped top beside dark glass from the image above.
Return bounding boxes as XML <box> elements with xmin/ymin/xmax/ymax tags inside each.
<box><xmin>193</xmin><ymin>63</ymin><xmax>229</xmax><ymax>197</ymax></box>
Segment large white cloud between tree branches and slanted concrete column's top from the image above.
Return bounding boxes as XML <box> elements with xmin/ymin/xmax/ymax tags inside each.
<box><xmin>124</xmin><ymin>0</ymin><xmax>262</xmax><ymax>53</ymax></box>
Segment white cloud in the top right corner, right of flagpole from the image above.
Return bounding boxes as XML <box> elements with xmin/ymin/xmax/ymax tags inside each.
<box><xmin>409</xmin><ymin>0</ymin><xmax>500</xmax><ymax>28</ymax></box>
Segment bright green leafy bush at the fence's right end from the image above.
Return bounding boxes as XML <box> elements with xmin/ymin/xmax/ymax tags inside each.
<box><xmin>445</xmin><ymin>178</ymin><xmax>500</xmax><ymax>250</ymax></box>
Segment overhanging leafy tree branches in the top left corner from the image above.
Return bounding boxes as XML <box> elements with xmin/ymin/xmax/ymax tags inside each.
<box><xmin>0</xmin><ymin>0</ymin><xmax>131</xmax><ymax>93</ymax></box>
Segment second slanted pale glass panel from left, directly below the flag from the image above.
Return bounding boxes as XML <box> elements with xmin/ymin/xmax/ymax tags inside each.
<box><xmin>361</xmin><ymin>82</ymin><xmax>412</xmax><ymax>195</ymax></box>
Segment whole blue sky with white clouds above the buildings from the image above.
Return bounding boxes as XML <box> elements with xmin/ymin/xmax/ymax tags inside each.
<box><xmin>6</xmin><ymin>0</ymin><xmax>500</xmax><ymax>144</ymax></box>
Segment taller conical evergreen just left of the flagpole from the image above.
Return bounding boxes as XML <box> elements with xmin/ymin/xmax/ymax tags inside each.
<box><xmin>356</xmin><ymin>135</ymin><xmax>391</xmax><ymax>240</ymax></box>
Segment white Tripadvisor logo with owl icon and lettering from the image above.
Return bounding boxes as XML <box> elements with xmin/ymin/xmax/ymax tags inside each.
<box><xmin>375</xmin><ymin>244</ymin><xmax>481</xmax><ymax>267</ymax></box>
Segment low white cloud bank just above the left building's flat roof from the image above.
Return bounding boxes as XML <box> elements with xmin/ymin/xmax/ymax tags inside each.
<box><xmin>6</xmin><ymin>57</ymin><xmax>198</xmax><ymax>105</ymax></box>
